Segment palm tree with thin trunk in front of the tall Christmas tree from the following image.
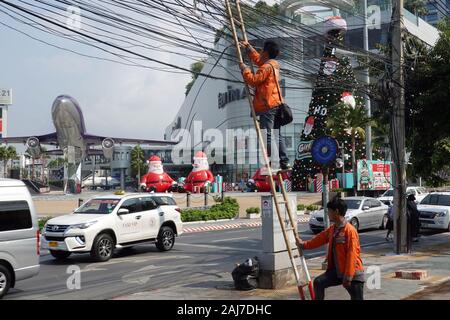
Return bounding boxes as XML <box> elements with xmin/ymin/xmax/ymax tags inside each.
<box><xmin>327</xmin><ymin>102</ymin><xmax>376</xmax><ymax>195</ymax></box>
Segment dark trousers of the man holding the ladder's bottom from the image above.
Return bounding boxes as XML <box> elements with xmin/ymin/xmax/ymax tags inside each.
<box><xmin>314</xmin><ymin>269</ymin><xmax>364</xmax><ymax>300</ymax></box>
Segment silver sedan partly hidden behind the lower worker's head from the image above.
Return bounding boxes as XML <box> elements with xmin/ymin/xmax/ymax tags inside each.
<box><xmin>309</xmin><ymin>197</ymin><xmax>388</xmax><ymax>233</ymax></box>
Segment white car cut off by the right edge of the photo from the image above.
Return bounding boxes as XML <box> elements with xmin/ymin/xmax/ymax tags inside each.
<box><xmin>417</xmin><ymin>192</ymin><xmax>450</xmax><ymax>232</ymax></box>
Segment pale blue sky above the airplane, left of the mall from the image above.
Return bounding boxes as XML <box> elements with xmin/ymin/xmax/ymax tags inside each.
<box><xmin>0</xmin><ymin>9</ymin><xmax>190</xmax><ymax>145</ymax></box>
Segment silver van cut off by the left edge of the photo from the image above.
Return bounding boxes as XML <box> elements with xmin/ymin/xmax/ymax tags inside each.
<box><xmin>0</xmin><ymin>179</ymin><xmax>40</xmax><ymax>299</ymax></box>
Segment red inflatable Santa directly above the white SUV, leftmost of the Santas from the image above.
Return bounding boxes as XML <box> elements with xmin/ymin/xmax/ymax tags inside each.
<box><xmin>141</xmin><ymin>156</ymin><xmax>175</xmax><ymax>192</ymax></box>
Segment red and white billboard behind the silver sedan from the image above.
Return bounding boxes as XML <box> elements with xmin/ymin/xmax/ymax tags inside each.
<box><xmin>357</xmin><ymin>160</ymin><xmax>392</xmax><ymax>191</ymax></box>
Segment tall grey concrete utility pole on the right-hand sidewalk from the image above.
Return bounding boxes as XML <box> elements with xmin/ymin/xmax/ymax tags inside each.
<box><xmin>391</xmin><ymin>0</ymin><xmax>409</xmax><ymax>254</ymax></box>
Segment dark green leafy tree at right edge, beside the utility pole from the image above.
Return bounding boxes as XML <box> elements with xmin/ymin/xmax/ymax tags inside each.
<box><xmin>405</xmin><ymin>18</ymin><xmax>450</xmax><ymax>185</ymax></box>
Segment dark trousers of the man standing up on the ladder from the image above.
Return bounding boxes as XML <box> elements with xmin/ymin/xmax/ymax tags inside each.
<box><xmin>258</xmin><ymin>108</ymin><xmax>289</xmax><ymax>164</ymax></box>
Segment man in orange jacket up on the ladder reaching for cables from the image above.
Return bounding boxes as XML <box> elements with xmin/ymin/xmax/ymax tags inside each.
<box><xmin>240</xmin><ymin>40</ymin><xmax>292</xmax><ymax>170</ymax></box>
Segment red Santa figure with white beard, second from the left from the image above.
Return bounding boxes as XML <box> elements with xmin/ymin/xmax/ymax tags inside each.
<box><xmin>184</xmin><ymin>151</ymin><xmax>214</xmax><ymax>192</ymax></box>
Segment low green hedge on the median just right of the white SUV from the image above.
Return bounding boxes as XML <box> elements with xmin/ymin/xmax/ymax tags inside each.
<box><xmin>181</xmin><ymin>197</ymin><xmax>241</xmax><ymax>222</ymax></box>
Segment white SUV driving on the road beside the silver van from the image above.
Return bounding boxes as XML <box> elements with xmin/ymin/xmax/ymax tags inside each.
<box><xmin>42</xmin><ymin>193</ymin><xmax>183</xmax><ymax>261</ymax></box>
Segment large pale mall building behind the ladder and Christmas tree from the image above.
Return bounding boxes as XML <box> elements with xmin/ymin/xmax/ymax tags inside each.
<box><xmin>165</xmin><ymin>0</ymin><xmax>438</xmax><ymax>182</ymax></box>
